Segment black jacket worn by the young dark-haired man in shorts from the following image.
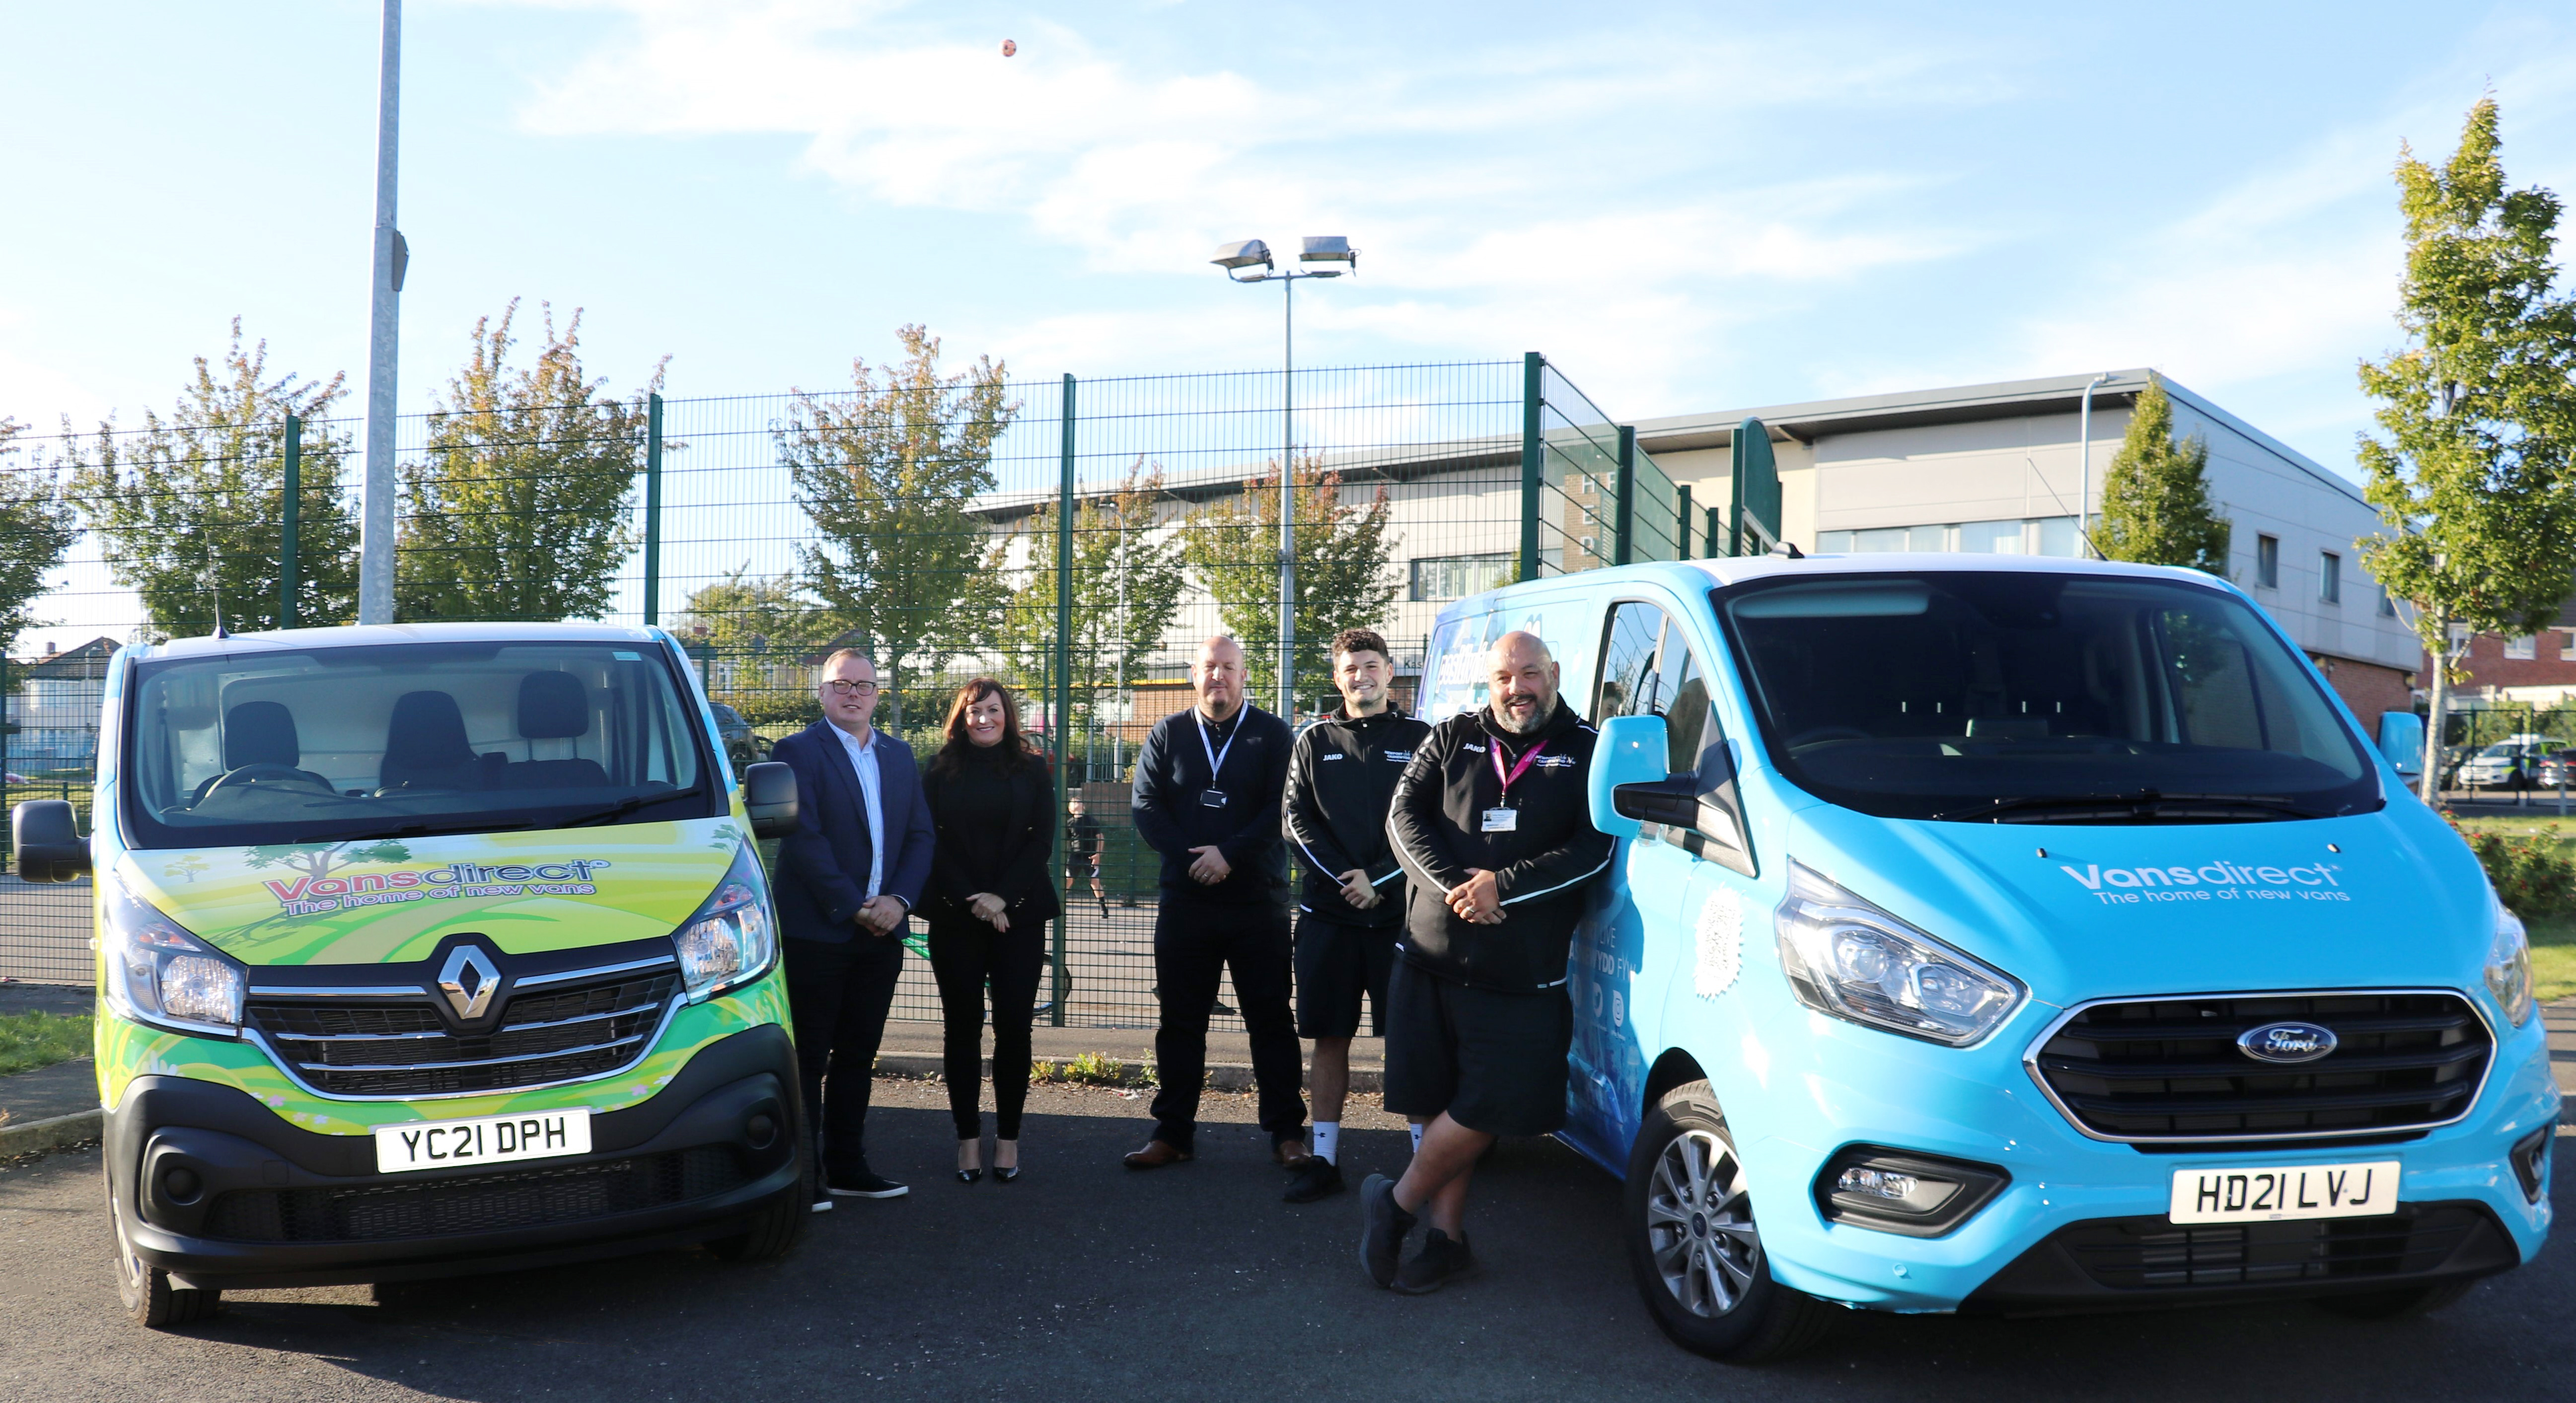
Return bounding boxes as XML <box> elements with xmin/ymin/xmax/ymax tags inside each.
<box><xmin>1288</xmin><ymin>705</ymin><xmax>1432</xmax><ymax>927</ymax></box>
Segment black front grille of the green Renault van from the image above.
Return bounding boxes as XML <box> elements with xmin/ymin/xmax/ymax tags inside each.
<box><xmin>245</xmin><ymin>965</ymin><xmax>680</xmax><ymax>1097</ymax></box>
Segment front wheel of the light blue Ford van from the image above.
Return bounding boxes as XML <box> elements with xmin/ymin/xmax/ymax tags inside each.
<box><xmin>1620</xmin><ymin>1081</ymin><xmax>1834</xmax><ymax>1364</ymax></box>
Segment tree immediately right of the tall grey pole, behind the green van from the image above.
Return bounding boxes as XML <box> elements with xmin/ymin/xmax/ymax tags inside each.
<box><xmin>394</xmin><ymin>298</ymin><xmax>677</xmax><ymax>621</ymax></box>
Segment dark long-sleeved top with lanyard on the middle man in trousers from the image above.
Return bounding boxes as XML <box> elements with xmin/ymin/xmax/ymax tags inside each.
<box><xmin>1133</xmin><ymin>703</ymin><xmax>1293</xmax><ymax>904</ymax></box>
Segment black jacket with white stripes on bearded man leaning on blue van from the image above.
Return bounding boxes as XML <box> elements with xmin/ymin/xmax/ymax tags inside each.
<box><xmin>1386</xmin><ymin>698</ymin><xmax>1610</xmax><ymax>994</ymax></box>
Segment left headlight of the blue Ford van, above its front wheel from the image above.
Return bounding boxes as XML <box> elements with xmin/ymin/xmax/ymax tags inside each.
<box><xmin>1777</xmin><ymin>862</ymin><xmax>2025</xmax><ymax>1048</ymax></box>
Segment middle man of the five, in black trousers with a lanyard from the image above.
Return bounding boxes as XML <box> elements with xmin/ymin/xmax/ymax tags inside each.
<box><xmin>1126</xmin><ymin>638</ymin><xmax>1306</xmax><ymax>1169</ymax></box>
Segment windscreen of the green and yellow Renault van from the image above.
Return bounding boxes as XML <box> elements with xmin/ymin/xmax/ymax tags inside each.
<box><xmin>124</xmin><ymin>643</ymin><xmax>727</xmax><ymax>847</ymax></box>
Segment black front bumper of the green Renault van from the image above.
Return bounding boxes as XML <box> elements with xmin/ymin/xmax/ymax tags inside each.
<box><xmin>106</xmin><ymin>1025</ymin><xmax>804</xmax><ymax>1290</ymax></box>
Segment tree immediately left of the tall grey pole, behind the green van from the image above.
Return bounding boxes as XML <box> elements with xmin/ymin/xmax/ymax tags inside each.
<box><xmin>62</xmin><ymin>317</ymin><xmax>358</xmax><ymax>636</ymax></box>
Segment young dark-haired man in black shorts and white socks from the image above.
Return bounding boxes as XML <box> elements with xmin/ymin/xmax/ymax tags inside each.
<box><xmin>1285</xmin><ymin>628</ymin><xmax>1432</xmax><ymax>1202</ymax></box>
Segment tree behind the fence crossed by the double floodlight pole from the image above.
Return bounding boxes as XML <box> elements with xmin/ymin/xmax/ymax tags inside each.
<box><xmin>1180</xmin><ymin>458</ymin><xmax>1399</xmax><ymax>698</ymax></box>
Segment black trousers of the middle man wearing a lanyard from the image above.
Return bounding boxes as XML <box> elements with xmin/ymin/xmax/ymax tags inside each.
<box><xmin>1154</xmin><ymin>891</ymin><xmax>1306</xmax><ymax>1151</ymax></box>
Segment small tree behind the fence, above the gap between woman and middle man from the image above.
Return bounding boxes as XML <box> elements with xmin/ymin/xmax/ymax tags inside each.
<box><xmin>994</xmin><ymin>458</ymin><xmax>1187</xmax><ymax>705</ymax></box>
